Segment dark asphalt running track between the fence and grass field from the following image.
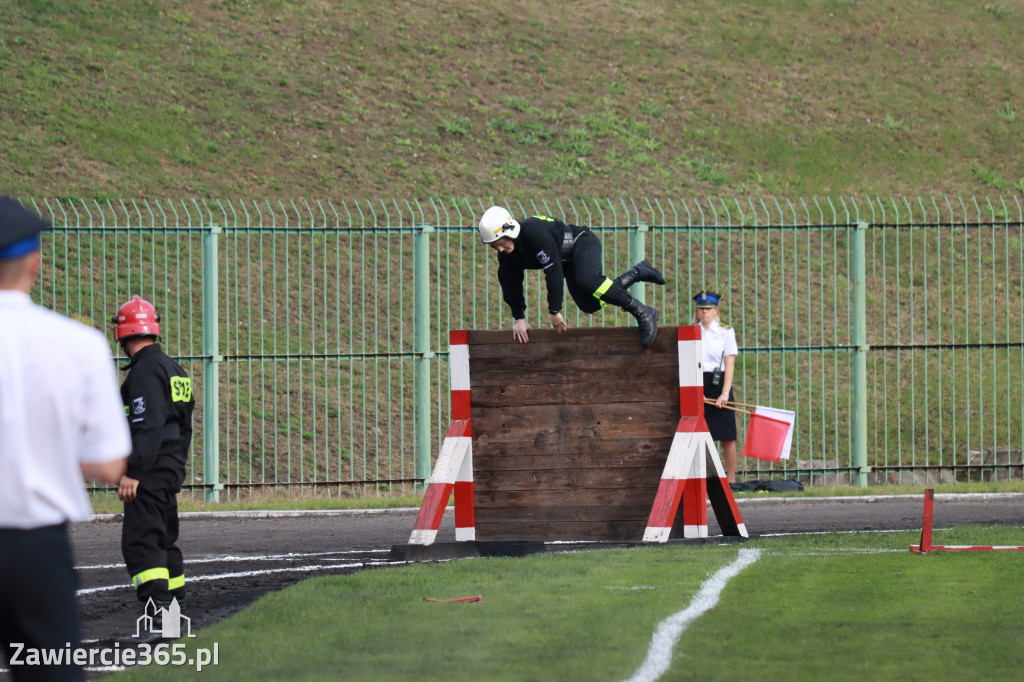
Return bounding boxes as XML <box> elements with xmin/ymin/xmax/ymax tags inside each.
<box><xmin>0</xmin><ymin>494</ymin><xmax>1024</xmax><ymax>679</ymax></box>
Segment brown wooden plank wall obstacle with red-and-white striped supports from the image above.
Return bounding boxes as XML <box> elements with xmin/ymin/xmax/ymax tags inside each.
<box><xmin>410</xmin><ymin>327</ymin><xmax>746</xmax><ymax>545</ymax></box>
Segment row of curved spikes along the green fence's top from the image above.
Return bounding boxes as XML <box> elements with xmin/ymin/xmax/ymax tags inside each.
<box><xmin>22</xmin><ymin>195</ymin><xmax>1024</xmax><ymax>230</ymax></box>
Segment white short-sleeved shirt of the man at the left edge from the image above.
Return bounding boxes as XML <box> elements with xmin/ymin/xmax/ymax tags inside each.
<box><xmin>0</xmin><ymin>291</ymin><xmax>131</xmax><ymax>528</ymax></box>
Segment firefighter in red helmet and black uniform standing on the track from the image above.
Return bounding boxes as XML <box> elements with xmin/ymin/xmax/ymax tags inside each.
<box><xmin>114</xmin><ymin>296</ymin><xmax>196</xmax><ymax>638</ymax></box>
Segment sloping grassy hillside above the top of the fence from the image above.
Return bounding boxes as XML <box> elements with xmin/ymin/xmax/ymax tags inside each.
<box><xmin>0</xmin><ymin>0</ymin><xmax>1024</xmax><ymax>199</ymax></box>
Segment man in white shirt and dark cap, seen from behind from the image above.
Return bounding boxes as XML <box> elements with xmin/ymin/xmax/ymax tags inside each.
<box><xmin>0</xmin><ymin>197</ymin><xmax>131</xmax><ymax>680</ymax></box>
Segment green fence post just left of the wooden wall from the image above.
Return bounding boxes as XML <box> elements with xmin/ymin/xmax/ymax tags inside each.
<box><xmin>416</xmin><ymin>225</ymin><xmax>434</xmax><ymax>485</ymax></box>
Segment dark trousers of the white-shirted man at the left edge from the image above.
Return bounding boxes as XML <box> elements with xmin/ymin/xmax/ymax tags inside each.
<box><xmin>0</xmin><ymin>524</ymin><xmax>85</xmax><ymax>682</ymax></box>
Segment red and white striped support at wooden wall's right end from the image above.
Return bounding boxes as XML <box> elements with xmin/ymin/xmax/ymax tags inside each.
<box><xmin>643</xmin><ymin>326</ymin><xmax>748</xmax><ymax>543</ymax></box>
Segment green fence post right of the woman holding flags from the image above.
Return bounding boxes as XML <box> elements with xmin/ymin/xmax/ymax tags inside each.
<box><xmin>852</xmin><ymin>221</ymin><xmax>871</xmax><ymax>487</ymax></box>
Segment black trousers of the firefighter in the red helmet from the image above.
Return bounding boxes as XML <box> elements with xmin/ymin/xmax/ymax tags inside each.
<box><xmin>121</xmin><ymin>476</ymin><xmax>185</xmax><ymax>605</ymax></box>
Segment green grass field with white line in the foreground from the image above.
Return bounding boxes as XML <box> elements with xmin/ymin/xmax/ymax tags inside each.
<box><xmin>112</xmin><ymin>526</ymin><xmax>1024</xmax><ymax>681</ymax></box>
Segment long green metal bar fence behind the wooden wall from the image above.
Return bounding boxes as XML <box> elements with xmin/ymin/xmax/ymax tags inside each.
<box><xmin>25</xmin><ymin>197</ymin><xmax>1024</xmax><ymax>498</ymax></box>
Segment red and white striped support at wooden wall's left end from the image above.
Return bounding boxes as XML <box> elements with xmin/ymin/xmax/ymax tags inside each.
<box><xmin>409</xmin><ymin>331</ymin><xmax>476</xmax><ymax>545</ymax></box>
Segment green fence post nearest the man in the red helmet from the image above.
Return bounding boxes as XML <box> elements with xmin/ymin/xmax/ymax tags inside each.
<box><xmin>203</xmin><ymin>225</ymin><xmax>224</xmax><ymax>502</ymax></box>
